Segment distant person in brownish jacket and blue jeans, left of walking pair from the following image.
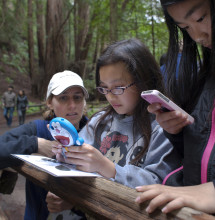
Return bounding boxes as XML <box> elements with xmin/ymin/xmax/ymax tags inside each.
<box><xmin>2</xmin><ymin>86</ymin><xmax>16</xmax><ymax>127</ymax></box>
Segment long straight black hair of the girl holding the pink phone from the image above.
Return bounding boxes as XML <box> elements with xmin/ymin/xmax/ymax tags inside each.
<box><xmin>160</xmin><ymin>0</ymin><xmax>215</xmax><ymax>112</ymax></box>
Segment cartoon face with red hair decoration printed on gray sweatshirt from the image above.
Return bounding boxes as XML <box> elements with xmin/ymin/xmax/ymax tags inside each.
<box><xmin>100</xmin><ymin>131</ymin><xmax>128</xmax><ymax>166</ymax></box>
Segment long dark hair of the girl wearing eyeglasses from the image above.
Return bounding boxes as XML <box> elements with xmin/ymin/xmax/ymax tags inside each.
<box><xmin>91</xmin><ymin>38</ymin><xmax>163</xmax><ymax>164</ymax></box>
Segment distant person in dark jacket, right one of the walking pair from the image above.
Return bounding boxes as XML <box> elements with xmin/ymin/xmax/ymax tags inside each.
<box><xmin>16</xmin><ymin>90</ymin><xmax>28</xmax><ymax>125</ymax></box>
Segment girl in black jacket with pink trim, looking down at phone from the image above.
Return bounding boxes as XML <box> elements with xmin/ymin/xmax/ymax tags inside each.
<box><xmin>136</xmin><ymin>0</ymin><xmax>215</xmax><ymax>214</ymax></box>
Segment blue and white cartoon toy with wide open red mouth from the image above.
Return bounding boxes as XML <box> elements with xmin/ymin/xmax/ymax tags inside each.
<box><xmin>49</xmin><ymin>117</ymin><xmax>84</xmax><ymax>157</ymax></box>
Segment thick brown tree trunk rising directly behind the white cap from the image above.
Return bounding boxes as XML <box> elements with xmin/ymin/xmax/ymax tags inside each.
<box><xmin>41</xmin><ymin>0</ymin><xmax>67</xmax><ymax>97</ymax></box>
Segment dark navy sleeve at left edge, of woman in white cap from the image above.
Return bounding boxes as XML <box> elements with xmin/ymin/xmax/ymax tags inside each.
<box><xmin>0</xmin><ymin>122</ymin><xmax>38</xmax><ymax>169</ymax></box>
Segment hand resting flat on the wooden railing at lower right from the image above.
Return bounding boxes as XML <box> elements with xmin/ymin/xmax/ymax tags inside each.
<box><xmin>135</xmin><ymin>182</ymin><xmax>215</xmax><ymax>213</ymax></box>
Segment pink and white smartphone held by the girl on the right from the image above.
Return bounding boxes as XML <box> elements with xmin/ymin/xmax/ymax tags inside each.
<box><xmin>141</xmin><ymin>90</ymin><xmax>194</xmax><ymax>123</ymax></box>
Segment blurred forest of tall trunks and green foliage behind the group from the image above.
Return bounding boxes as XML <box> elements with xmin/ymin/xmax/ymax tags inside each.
<box><xmin>0</xmin><ymin>0</ymin><xmax>168</xmax><ymax>102</ymax></box>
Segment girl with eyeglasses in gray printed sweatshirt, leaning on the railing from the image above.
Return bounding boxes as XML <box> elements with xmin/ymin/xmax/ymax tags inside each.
<box><xmin>53</xmin><ymin>39</ymin><xmax>179</xmax><ymax>187</ymax></box>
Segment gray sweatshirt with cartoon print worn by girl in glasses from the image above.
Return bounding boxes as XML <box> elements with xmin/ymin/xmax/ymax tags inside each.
<box><xmin>79</xmin><ymin>112</ymin><xmax>181</xmax><ymax>188</ymax></box>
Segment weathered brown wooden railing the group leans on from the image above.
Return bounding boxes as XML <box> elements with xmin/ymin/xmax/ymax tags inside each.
<box><xmin>14</xmin><ymin>163</ymin><xmax>215</xmax><ymax>220</ymax></box>
